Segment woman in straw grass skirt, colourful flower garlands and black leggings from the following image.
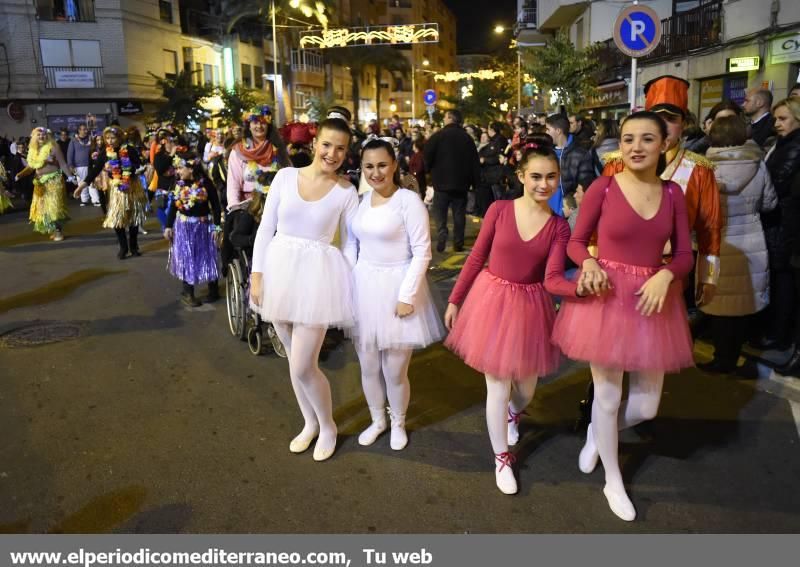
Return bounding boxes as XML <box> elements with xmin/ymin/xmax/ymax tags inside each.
<box><xmin>73</xmin><ymin>126</ymin><xmax>147</xmax><ymax>260</ymax></box>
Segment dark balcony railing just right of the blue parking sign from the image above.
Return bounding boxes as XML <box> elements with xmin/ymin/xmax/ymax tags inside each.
<box><xmin>644</xmin><ymin>0</ymin><xmax>722</xmax><ymax>61</ymax></box>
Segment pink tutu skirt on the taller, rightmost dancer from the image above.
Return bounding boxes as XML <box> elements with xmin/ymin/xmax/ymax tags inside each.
<box><xmin>553</xmin><ymin>260</ymin><xmax>694</xmax><ymax>372</ymax></box>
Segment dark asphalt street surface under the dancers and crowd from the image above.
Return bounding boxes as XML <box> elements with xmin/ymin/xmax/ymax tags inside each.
<box><xmin>0</xmin><ymin>205</ymin><xmax>800</xmax><ymax>533</ymax></box>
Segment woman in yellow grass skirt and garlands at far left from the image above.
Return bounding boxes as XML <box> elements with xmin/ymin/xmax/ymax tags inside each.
<box><xmin>16</xmin><ymin>127</ymin><xmax>72</xmax><ymax>242</ymax></box>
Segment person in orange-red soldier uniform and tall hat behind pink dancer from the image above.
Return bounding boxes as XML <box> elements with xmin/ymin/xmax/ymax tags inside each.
<box><xmin>603</xmin><ymin>75</ymin><xmax>723</xmax><ymax>307</ymax></box>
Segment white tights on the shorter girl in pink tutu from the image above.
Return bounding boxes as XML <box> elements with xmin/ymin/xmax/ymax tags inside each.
<box><xmin>486</xmin><ymin>374</ymin><xmax>539</xmax><ymax>455</ymax></box>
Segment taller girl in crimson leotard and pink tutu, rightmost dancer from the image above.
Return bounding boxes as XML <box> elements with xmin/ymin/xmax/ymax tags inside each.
<box><xmin>553</xmin><ymin>111</ymin><xmax>694</xmax><ymax>521</ymax></box>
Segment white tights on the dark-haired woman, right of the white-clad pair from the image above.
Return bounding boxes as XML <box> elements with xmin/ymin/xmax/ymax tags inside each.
<box><xmin>356</xmin><ymin>349</ymin><xmax>413</xmax><ymax>416</ymax></box>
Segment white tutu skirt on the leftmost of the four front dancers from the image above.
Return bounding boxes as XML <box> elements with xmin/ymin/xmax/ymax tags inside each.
<box><xmin>250</xmin><ymin>234</ymin><xmax>355</xmax><ymax>329</ymax></box>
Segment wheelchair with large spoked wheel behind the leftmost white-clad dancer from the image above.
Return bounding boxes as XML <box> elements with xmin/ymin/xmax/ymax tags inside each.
<box><xmin>224</xmin><ymin>210</ymin><xmax>286</xmax><ymax>358</ymax></box>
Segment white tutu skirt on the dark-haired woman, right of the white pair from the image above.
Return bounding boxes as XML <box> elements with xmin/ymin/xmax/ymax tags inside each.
<box><xmin>352</xmin><ymin>260</ymin><xmax>444</xmax><ymax>350</ymax></box>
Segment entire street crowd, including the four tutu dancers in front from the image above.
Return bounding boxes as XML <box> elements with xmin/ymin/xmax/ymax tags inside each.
<box><xmin>0</xmin><ymin>76</ymin><xmax>800</xmax><ymax>521</ymax></box>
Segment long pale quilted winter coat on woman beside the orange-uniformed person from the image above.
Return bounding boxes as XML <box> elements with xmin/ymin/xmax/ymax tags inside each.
<box><xmin>700</xmin><ymin>141</ymin><xmax>778</xmax><ymax>316</ymax></box>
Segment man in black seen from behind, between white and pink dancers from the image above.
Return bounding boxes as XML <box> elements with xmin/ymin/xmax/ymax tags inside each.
<box><xmin>425</xmin><ymin>109</ymin><xmax>481</xmax><ymax>252</ymax></box>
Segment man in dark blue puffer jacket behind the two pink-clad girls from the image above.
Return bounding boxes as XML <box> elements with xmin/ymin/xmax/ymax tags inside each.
<box><xmin>545</xmin><ymin>114</ymin><xmax>596</xmax><ymax>216</ymax></box>
